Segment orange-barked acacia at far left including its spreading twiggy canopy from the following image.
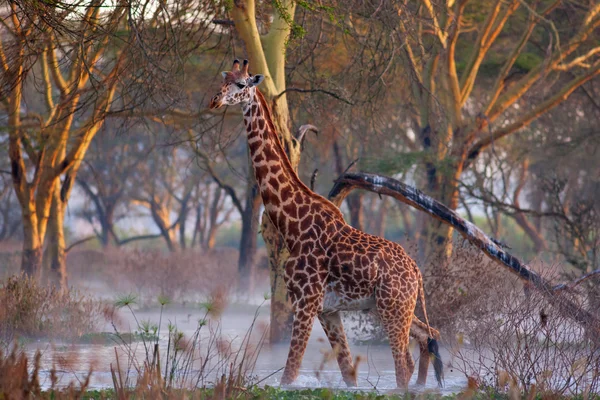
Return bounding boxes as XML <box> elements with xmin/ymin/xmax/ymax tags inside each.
<box><xmin>0</xmin><ymin>0</ymin><xmax>214</xmax><ymax>287</ymax></box>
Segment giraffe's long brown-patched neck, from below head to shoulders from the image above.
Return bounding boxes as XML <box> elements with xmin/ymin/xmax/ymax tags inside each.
<box><xmin>243</xmin><ymin>89</ymin><xmax>343</xmax><ymax>248</ymax></box>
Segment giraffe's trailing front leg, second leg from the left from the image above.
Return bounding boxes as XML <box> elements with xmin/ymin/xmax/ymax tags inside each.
<box><xmin>319</xmin><ymin>311</ymin><xmax>356</xmax><ymax>386</ymax></box>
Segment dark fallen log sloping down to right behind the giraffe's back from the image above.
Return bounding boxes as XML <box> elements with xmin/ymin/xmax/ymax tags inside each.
<box><xmin>329</xmin><ymin>172</ymin><xmax>600</xmax><ymax>334</ymax></box>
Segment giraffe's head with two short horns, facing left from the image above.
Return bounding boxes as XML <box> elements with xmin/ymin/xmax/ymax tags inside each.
<box><xmin>209</xmin><ymin>60</ymin><xmax>265</xmax><ymax>109</ymax></box>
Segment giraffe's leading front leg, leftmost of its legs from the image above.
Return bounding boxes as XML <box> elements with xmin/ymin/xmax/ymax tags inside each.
<box><xmin>281</xmin><ymin>302</ymin><xmax>317</xmax><ymax>385</ymax></box>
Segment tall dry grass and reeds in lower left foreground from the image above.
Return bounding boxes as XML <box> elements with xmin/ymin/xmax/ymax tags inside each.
<box><xmin>0</xmin><ymin>292</ymin><xmax>268</xmax><ymax>399</ymax></box>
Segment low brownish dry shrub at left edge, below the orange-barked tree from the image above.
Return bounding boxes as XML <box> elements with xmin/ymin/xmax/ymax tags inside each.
<box><xmin>0</xmin><ymin>275</ymin><xmax>109</xmax><ymax>344</ymax></box>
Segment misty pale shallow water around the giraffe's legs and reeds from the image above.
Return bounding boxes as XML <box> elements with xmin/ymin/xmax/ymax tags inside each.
<box><xmin>27</xmin><ymin>307</ymin><xmax>466</xmax><ymax>394</ymax></box>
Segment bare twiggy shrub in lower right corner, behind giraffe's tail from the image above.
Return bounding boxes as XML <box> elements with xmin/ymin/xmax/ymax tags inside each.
<box><xmin>452</xmin><ymin>268</ymin><xmax>600</xmax><ymax>398</ymax></box>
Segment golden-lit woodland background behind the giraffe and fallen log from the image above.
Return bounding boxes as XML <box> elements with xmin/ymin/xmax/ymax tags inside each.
<box><xmin>0</xmin><ymin>0</ymin><xmax>600</xmax><ymax>340</ymax></box>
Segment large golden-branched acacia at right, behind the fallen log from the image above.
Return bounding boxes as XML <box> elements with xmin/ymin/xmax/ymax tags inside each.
<box><xmin>396</xmin><ymin>0</ymin><xmax>600</xmax><ymax>268</ymax></box>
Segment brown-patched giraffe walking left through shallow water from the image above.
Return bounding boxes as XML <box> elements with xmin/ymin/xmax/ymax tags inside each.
<box><xmin>209</xmin><ymin>60</ymin><xmax>443</xmax><ymax>388</ymax></box>
